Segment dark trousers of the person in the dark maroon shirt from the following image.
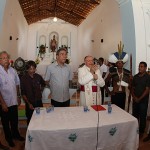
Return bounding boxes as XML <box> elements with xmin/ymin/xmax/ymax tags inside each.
<box><xmin>25</xmin><ymin>100</ymin><xmax>43</xmax><ymax>125</ymax></box>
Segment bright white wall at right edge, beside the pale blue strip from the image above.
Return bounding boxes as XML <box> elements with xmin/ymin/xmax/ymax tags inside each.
<box><xmin>132</xmin><ymin>0</ymin><xmax>150</xmax><ymax>72</ymax></box>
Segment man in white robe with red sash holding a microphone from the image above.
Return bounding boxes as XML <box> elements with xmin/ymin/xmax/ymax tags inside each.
<box><xmin>78</xmin><ymin>56</ymin><xmax>105</xmax><ymax>106</ymax></box>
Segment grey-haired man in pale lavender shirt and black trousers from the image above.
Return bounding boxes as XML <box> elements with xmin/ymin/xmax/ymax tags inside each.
<box><xmin>0</xmin><ymin>51</ymin><xmax>24</xmax><ymax>147</ymax></box>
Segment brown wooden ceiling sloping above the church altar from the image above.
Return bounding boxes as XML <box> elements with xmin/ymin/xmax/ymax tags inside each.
<box><xmin>18</xmin><ymin>0</ymin><xmax>101</xmax><ymax>26</ymax></box>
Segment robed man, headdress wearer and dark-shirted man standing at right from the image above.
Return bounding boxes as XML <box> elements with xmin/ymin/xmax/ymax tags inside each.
<box><xmin>78</xmin><ymin>52</ymin><xmax>150</xmax><ymax>141</ymax></box>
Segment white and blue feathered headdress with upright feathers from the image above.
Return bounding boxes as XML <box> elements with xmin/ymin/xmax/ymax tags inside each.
<box><xmin>108</xmin><ymin>41</ymin><xmax>128</xmax><ymax>63</ymax></box>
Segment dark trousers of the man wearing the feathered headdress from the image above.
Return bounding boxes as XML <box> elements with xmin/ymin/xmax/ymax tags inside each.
<box><xmin>111</xmin><ymin>92</ymin><xmax>126</xmax><ymax>109</ymax></box>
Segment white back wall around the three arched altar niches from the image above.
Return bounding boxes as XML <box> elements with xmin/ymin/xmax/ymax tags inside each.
<box><xmin>27</xmin><ymin>19</ymin><xmax>78</xmax><ymax>71</ymax></box>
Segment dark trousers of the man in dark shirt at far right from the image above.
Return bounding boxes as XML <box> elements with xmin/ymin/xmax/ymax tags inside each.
<box><xmin>132</xmin><ymin>100</ymin><xmax>148</xmax><ymax>133</ymax></box>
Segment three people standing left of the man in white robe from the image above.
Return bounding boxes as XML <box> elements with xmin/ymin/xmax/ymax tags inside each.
<box><xmin>0</xmin><ymin>48</ymin><xmax>71</xmax><ymax>147</ymax></box>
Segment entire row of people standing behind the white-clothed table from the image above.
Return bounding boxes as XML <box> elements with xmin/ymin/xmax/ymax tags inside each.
<box><xmin>0</xmin><ymin>48</ymin><xmax>150</xmax><ymax>147</ymax></box>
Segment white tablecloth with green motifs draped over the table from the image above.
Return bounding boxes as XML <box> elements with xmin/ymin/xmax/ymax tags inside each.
<box><xmin>25</xmin><ymin>105</ymin><xmax>139</xmax><ymax>150</ymax></box>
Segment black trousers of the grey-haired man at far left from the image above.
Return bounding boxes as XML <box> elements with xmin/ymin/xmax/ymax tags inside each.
<box><xmin>0</xmin><ymin>105</ymin><xmax>20</xmax><ymax>142</ymax></box>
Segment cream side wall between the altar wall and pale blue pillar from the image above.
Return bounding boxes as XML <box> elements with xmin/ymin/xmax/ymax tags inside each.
<box><xmin>78</xmin><ymin>0</ymin><xmax>122</xmax><ymax>63</ymax></box>
